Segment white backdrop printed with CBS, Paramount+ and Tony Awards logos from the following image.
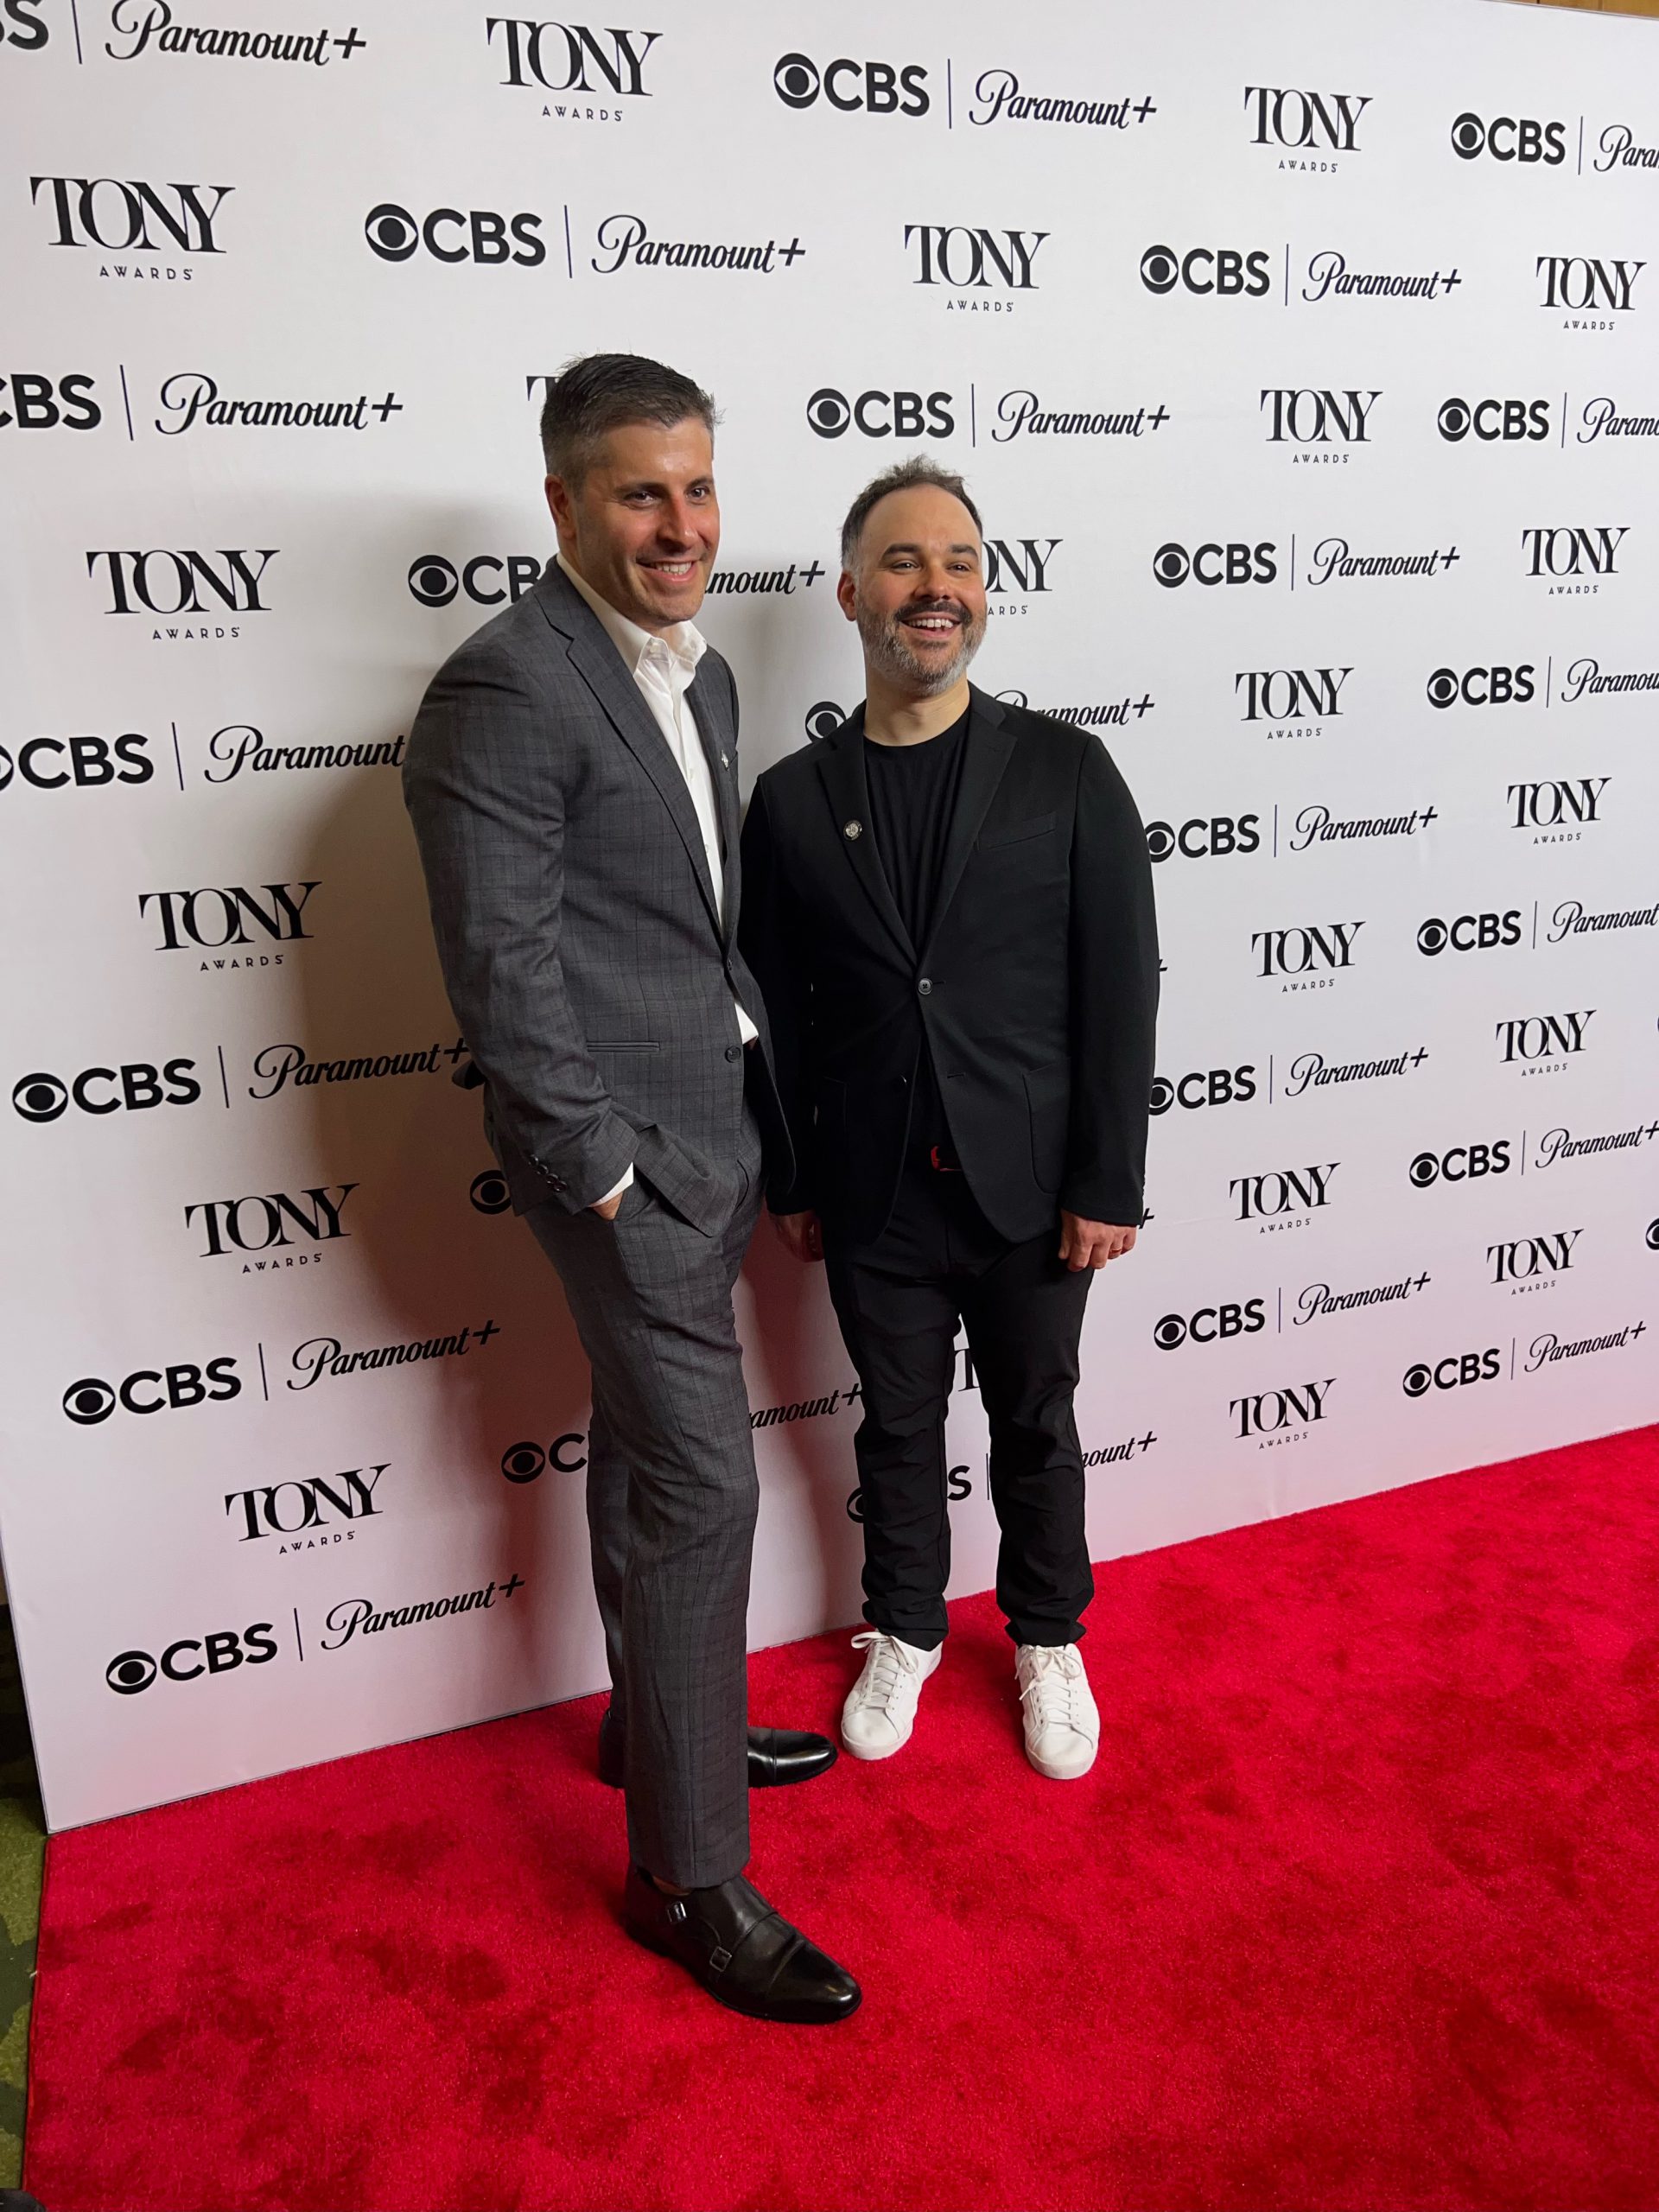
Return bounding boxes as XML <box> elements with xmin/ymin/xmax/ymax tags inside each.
<box><xmin>0</xmin><ymin>0</ymin><xmax>1659</xmax><ymax>1827</ymax></box>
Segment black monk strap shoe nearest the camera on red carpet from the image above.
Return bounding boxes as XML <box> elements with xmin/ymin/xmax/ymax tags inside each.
<box><xmin>621</xmin><ymin>1865</ymin><xmax>862</xmax><ymax>2026</ymax></box>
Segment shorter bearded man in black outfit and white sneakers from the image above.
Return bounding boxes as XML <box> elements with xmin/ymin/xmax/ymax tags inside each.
<box><xmin>741</xmin><ymin>460</ymin><xmax>1159</xmax><ymax>1781</ymax></box>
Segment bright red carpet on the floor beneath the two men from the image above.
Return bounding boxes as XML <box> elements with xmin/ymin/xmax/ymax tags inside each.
<box><xmin>27</xmin><ymin>1429</ymin><xmax>1659</xmax><ymax>2212</ymax></box>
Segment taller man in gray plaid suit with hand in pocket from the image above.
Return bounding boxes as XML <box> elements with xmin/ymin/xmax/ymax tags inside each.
<box><xmin>403</xmin><ymin>354</ymin><xmax>858</xmax><ymax>2022</ymax></box>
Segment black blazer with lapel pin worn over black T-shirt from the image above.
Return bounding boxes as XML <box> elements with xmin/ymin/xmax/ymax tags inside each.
<box><xmin>739</xmin><ymin>690</ymin><xmax>1159</xmax><ymax>1243</ymax></box>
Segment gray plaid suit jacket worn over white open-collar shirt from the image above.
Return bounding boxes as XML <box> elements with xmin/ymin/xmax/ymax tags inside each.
<box><xmin>403</xmin><ymin>566</ymin><xmax>787</xmax><ymax>1234</ymax></box>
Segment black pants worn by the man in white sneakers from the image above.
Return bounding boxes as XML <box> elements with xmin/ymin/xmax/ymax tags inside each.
<box><xmin>823</xmin><ymin>1164</ymin><xmax>1095</xmax><ymax>1650</ymax></box>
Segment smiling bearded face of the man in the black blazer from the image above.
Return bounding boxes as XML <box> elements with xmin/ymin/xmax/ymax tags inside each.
<box><xmin>836</xmin><ymin>485</ymin><xmax>987</xmax><ymax>699</ymax></box>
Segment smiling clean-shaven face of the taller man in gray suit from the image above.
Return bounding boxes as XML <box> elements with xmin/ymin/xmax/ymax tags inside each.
<box><xmin>546</xmin><ymin>416</ymin><xmax>721</xmax><ymax>632</ymax></box>
